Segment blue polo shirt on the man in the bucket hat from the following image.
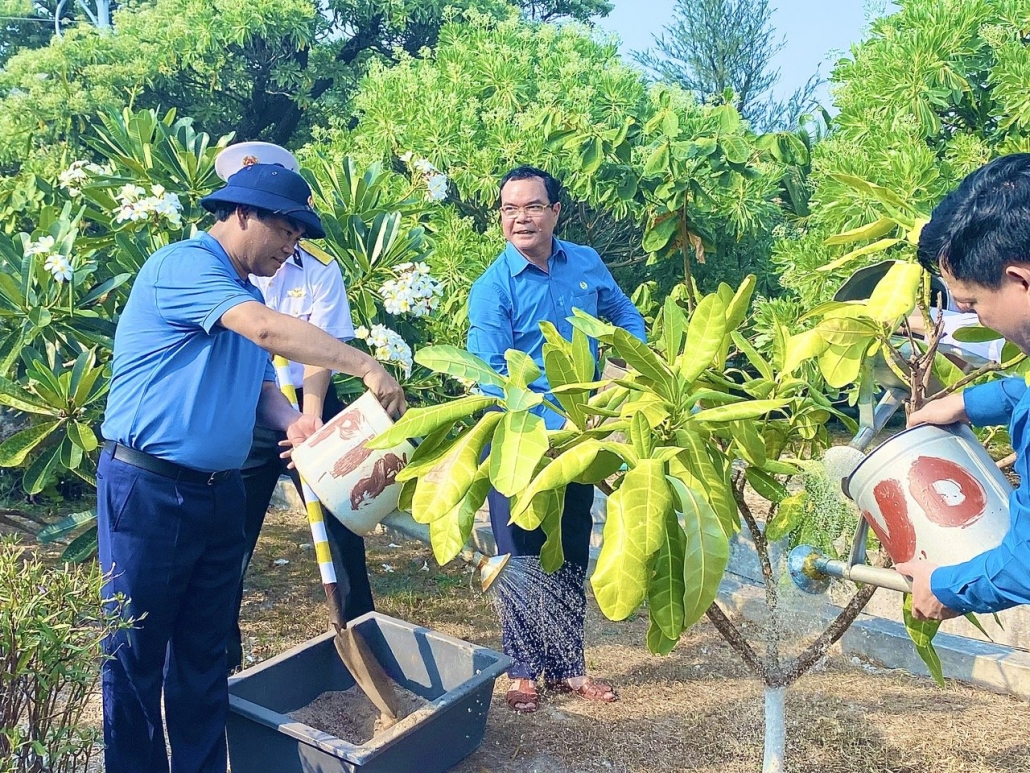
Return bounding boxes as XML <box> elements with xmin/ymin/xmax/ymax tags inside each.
<box><xmin>102</xmin><ymin>233</ymin><xmax>275</xmax><ymax>471</ymax></box>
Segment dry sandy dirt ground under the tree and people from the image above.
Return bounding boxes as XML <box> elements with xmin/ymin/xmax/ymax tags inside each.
<box><xmin>12</xmin><ymin>502</ymin><xmax>1030</xmax><ymax>773</ymax></box>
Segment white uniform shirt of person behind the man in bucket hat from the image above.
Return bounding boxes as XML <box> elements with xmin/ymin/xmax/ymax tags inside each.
<box><xmin>250</xmin><ymin>247</ymin><xmax>354</xmax><ymax>388</ymax></box>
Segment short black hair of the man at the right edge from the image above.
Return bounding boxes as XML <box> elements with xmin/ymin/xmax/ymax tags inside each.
<box><xmin>917</xmin><ymin>153</ymin><xmax>1030</xmax><ymax>289</ymax></box>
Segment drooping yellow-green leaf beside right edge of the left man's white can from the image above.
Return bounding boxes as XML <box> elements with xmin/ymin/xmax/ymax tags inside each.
<box><xmin>411</xmin><ymin>411</ymin><xmax>504</xmax><ymax>524</ymax></box>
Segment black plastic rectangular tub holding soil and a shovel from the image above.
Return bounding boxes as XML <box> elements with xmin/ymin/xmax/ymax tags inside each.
<box><xmin>228</xmin><ymin>612</ymin><xmax>510</xmax><ymax>773</ymax></box>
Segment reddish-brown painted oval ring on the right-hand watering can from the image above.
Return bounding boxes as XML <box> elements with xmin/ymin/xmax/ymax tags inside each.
<box><xmin>908</xmin><ymin>457</ymin><xmax>987</xmax><ymax>529</ymax></box>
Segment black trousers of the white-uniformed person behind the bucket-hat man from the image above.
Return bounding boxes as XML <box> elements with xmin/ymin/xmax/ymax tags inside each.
<box><xmin>227</xmin><ymin>384</ymin><xmax>375</xmax><ymax>671</ymax></box>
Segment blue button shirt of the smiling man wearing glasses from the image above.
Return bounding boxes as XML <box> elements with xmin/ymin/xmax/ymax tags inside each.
<box><xmin>469</xmin><ymin>239</ymin><xmax>647</xmax><ymax>430</ymax></box>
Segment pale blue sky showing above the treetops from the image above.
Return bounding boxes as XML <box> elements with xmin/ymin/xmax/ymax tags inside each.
<box><xmin>598</xmin><ymin>0</ymin><xmax>888</xmax><ymax>106</ymax></box>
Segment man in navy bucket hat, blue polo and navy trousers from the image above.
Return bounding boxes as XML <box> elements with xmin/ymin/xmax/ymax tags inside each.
<box><xmin>97</xmin><ymin>164</ymin><xmax>405</xmax><ymax>773</ymax></box>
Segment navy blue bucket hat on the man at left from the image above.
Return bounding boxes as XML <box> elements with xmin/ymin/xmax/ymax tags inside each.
<box><xmin>200</xmin><ymin>164</ymin><xmax>325</xmax><ymax>239</ymax></box>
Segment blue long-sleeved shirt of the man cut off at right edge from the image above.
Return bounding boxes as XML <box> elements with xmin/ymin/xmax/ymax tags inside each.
<box><xmin>930</xmin><ymin>378</ymin><xmax>1030</xmax><ymax>613</ymax></box>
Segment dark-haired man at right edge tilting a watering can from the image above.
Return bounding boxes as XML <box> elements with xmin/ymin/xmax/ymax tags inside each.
<box><xmin>896</xmin><ymin>154</ymin><xmax>1030</xmax><ymax>619</ymax></box>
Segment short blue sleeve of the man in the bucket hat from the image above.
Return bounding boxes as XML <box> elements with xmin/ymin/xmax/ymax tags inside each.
<box><xmin>153</xmin><ymin>248</ymin><xmax>259</xmax><ymax>333</ymax></box>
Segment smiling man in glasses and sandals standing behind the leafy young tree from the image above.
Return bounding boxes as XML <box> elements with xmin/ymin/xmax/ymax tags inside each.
<box><xmin>469</xmin><ymin>166</ymin><xmax>646</xmax><ymax>713</ymax></box>
